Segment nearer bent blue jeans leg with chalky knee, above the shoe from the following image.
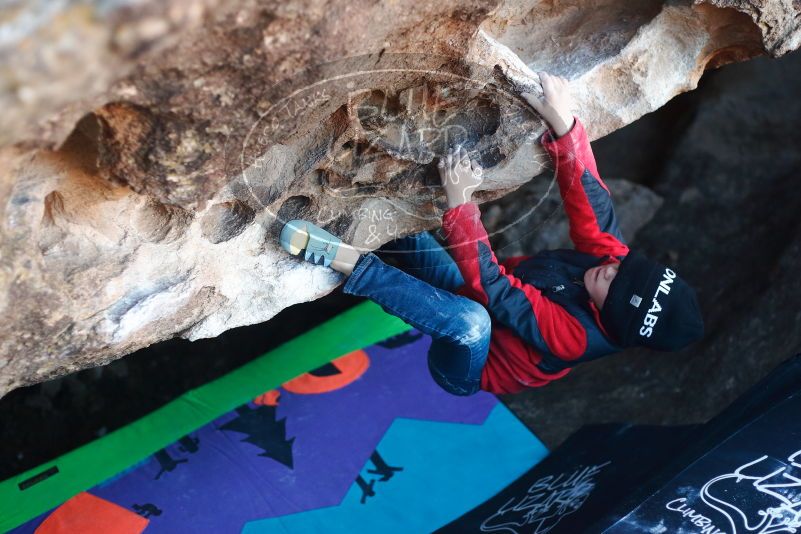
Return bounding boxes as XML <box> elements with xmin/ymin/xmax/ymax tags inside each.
<box><xmin>343</xmin><ymin>253</ymin><xmax>491</xmax><ymax>395</ymax></box>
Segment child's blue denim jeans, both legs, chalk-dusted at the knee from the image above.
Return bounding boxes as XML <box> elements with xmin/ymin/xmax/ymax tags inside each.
<box><xmin>343</xmin><ymin>232</ymin><xmax>491</xmax><ymax>395</ymax></box>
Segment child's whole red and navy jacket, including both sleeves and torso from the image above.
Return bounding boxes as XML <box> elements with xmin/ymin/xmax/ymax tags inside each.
<box><xmin>442</xmin><ymin>118</ymin><xmax>629</xmax><ymax>393</ymax></box>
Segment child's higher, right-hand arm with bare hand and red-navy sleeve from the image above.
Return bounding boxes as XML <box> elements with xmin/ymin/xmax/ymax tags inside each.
<box><xmin>523</xmin><ymin>72</ymin><xmax>629</xmax><ymax>256</ymax></box>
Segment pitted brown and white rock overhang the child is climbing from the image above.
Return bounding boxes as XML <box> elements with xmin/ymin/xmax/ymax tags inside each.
<box><xmin>0</xmin><ymin>0</ymin><xmax>801</xmax><ymax>394</ymax></box>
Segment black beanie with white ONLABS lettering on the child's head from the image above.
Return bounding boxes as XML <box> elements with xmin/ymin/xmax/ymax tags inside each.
<box><xmin>601</xmin><ymin>252</ymin><xmax>704</xmax><ymax>350</ymax></box>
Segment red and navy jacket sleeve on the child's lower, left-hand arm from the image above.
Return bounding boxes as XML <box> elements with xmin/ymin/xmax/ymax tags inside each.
<box><xmin>442</xmin><ymin>202</ymin><xmax>587</xmax><ymax>360</ymax></box>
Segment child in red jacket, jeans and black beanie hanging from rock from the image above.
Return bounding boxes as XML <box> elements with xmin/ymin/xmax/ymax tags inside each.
<box><xmin>281</xmin><ymin>72</ymin><xmax>703</xmax><ymax>395</ymax></box>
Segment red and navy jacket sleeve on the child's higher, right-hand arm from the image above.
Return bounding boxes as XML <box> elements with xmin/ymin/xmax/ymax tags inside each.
<box><xmin>540</xmin><ymin>117</ymin><xmax>629</xmax><ymax>257</ymax></box>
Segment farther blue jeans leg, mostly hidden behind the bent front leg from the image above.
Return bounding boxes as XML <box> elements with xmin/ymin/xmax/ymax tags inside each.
<box><xmin>381</xmin><ymin>232</ymin><xmax>464</xmax><ymax>291</ymax></box>
